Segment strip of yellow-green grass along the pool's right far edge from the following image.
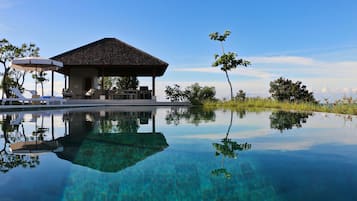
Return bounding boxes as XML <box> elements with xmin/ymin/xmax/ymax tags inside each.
<box><xmin>203</xmin><ymin>98</ymin><xmax>357</xmax><ymax>115</ymax></box>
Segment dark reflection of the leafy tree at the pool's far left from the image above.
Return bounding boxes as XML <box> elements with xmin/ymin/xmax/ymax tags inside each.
<box><xmin>0</xmin><ymin>115</ymin><xmax>40</xmax><ymax>173</ymax></box>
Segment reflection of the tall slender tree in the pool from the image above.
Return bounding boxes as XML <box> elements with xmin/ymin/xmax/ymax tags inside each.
<box><xmin>211</xmin><ymin>111</ymin><xmax>252</xmax><ymax>179</ymax></box>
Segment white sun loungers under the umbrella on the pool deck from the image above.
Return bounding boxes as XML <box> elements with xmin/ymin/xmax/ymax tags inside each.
<box><xmin>1</xmin><ymin>87</ymin><xmax>66</xmax><ymax>105</ymax></box>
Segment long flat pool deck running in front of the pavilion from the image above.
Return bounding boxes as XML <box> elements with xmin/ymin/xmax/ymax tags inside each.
<box><xmin>0</xmin><ymin>99</ymin><xmax>191</xmax><ymax>111</ymax></box>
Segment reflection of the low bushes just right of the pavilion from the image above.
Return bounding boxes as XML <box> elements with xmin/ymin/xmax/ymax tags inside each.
<box><xmin>165</xmin><ymin>107</ymin><xmax>216</xmax><ymax>126</ymax></box>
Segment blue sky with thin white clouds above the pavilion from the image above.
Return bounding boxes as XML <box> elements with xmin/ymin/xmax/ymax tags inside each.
<box><xmin>0</xmin><ymin>0</ymin><xmax>357</xmax><ymax>100</ymax></box>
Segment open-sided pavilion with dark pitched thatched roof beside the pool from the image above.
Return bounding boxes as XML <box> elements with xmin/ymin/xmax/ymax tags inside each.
<box><xmin>51</xmin><ymin>38</ymin><xmax>168</xmax><ymax>99</ymax></box>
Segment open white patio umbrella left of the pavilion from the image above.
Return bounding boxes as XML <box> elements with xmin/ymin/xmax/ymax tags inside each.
<box><xmin>10</xmin><ymin>57</ymin><xmax>63</xmax><ymax>94</ymax></box>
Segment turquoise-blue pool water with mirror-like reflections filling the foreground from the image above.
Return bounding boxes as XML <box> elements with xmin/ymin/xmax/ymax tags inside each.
<box><xmin>0</xmin><ymin>107</ymin><xmax>357</xmax><ymax>201</ymax></box>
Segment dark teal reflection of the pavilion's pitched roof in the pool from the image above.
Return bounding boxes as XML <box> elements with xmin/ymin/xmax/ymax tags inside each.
<box><xmin>56</xmin><ymin>133</ymin><xmax>168</xmax><ymax>172</ymax></box>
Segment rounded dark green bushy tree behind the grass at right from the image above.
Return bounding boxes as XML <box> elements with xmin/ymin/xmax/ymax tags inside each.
<box><xmin>269</xmin><ymin>77</ymin><xmax>316</xmax><ymax>103</ymax></box>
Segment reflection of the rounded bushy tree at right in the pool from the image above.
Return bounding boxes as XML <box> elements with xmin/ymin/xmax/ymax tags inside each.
<box><xmin>269</xmin><ymin>111</ymin><xmax>312</xmax><ymax>132</ymax></box>
